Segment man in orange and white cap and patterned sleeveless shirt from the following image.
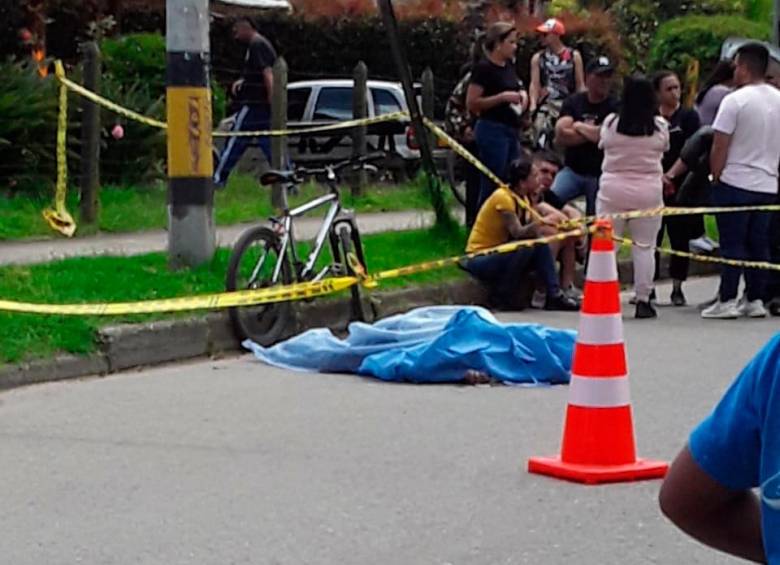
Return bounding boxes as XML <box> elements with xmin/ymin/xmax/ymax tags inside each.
<box><xmin>529</xmin><ymin>18</ymin><xmax>585</xmax><ymax>112</ymax></box>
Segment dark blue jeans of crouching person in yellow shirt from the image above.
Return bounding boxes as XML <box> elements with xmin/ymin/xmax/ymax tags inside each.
<box><xmin>465</xmin><ymin>245</ymin><xmax>561</xmax><ymax>304</ymax></box>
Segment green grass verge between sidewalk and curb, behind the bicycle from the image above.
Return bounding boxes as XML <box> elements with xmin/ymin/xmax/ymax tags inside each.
<box><xmin>0</xmin><ymin>228</ymin><xmax>465</xmax><ymax>363</ymax></box>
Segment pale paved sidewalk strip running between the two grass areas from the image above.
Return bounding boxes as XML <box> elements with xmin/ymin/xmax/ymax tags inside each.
<box><xmin>0</xmin><ymin>210</ymin><xmax>434</xmax><ymax>265</ymax></box>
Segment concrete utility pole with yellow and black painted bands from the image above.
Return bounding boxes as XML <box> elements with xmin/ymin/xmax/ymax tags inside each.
<box><xmin>166</xmin><ymin>0</ymin><xmax>216</xmax><ymax>268</ymax></box>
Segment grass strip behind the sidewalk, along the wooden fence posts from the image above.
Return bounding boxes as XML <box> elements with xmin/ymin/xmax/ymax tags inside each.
<box><xmin>0</xmin><ymin>173</ymin><xmax>431</xmax><ymax>240</ymax></box>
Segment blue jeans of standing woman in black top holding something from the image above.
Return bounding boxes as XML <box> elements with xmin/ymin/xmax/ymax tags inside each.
<box><xmin>474</xmin><ymin>120</ymin><xmax>520</xmax><ymax>210</ymax></box>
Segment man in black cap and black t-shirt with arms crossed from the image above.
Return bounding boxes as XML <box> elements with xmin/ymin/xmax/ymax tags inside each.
<box><xmin>552</xmin><ymin>56</ymin><xmax>618</xmax><ymax>216</ymax></box>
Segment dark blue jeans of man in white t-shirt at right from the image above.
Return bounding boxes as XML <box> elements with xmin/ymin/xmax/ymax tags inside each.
<box><xmin>711</xmin><ymin>182</ymin><xmax>775</xmax><ymax>302</ymax></box>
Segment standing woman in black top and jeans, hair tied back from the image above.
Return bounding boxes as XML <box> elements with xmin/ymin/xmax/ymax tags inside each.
<box><xmin>466</xmin><ymin>22</ymin><xmax>528</xmax><ymax>207</ymax></box>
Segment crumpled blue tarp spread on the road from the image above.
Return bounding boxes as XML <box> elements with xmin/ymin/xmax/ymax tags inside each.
<box><xmin>244</xmin><ymin>306</ymin><xmax>576</xmax><ymax>384</ymax></box>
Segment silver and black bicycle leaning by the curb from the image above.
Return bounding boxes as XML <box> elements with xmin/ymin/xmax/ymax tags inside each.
<box><xmin>225</xmin><ymin>153</ymin><xmax>385</xmax><ymax>346</ymax></box>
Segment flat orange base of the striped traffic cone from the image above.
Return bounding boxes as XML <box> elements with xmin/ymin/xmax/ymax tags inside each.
<box><xmin>528</xmin><ymin>457</ymin><xmax>669</xmax><ymax>485</ymax></box>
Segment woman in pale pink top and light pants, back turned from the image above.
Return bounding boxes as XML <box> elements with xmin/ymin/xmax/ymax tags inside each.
<box><xmin>596</xmin><ymin>76</ymin><xmax>669</xmax><ymax>318</ymax></box>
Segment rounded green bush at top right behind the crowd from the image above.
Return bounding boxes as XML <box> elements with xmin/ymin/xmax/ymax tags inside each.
<box><xmin>650</xmin><ymin>16</ymin><xmax>770</xmax><ymax>76</ymax></box>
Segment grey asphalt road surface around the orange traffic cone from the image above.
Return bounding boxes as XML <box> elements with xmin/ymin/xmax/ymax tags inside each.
<box><xmin>0</xmin><ymin>280</ymin><xmax>780</xmax><ymax>565</ymax></box>
